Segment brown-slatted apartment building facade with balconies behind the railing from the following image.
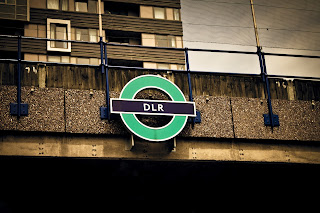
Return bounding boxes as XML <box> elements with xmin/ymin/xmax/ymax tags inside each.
<box><xmin>0</xmin><ymin>0</ymin><xmax>185</xmax><ymax>70</ymax></box>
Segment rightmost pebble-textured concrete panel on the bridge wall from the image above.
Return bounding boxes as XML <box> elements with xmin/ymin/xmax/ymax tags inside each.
<box><xmin>232</xmin><ymin>98</ymin><xmax>320</xmax><ymax>141</ymax></box>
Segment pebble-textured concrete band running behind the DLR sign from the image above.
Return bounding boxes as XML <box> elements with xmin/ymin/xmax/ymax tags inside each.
<box><xmin>0</xmin><ymin>86</ymin><xmax>320</xmax><ymax>141</ymax></box>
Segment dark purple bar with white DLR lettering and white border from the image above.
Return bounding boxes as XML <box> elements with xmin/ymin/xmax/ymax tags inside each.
<box><xmin>110</xmin><ymin>98</ymin><xmax>196</xmax><ymax>117</ymax></box>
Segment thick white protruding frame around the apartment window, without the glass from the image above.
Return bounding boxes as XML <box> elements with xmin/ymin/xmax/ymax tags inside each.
<box><xmin>47</xmin><ymin>18</ymin><xmax>71</xmax><ymax>52</ymax></box>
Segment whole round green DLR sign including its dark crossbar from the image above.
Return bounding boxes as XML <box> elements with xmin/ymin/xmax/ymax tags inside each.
<box><xmin>111</xmin><ymin>75</ymin><xmax>195</xmax><ymax>141</ymax></box>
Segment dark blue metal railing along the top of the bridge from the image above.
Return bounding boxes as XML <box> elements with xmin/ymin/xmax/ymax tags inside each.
<box><xmin>0</xmin><ymin>35</ymin><xmax>320</xmax><ymax>125</ymax></box>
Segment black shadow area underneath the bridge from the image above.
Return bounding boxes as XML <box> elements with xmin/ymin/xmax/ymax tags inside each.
<box><xmin>0</xmin><ymin>157</ymin><xmax>320</xmax><ymax>213</ymax></box>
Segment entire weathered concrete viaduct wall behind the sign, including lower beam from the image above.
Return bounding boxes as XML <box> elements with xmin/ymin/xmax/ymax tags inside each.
<box><xmin>0</xmin><ymin>63</ymin><xmax>320</xmax><ymax>163</ymax></box>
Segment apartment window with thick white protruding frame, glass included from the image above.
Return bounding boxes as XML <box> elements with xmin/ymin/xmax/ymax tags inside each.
<box><xmin>47</xmin><ymin>19</ymin><xmax>71</xmax><ymax>52</ymax></box>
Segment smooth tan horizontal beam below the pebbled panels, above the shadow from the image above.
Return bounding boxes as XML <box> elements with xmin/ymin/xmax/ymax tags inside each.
<box><xmin>0</xmin><ymin>132</ymin><xmax>320</xmax><ymax>164</ymax></box>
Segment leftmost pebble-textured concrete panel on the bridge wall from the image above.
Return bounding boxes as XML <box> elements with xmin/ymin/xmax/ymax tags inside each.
<box><xmin>0</xmin><ymin>86</ymin><xmax>65</xmax><ymax>132</ymax></box>
